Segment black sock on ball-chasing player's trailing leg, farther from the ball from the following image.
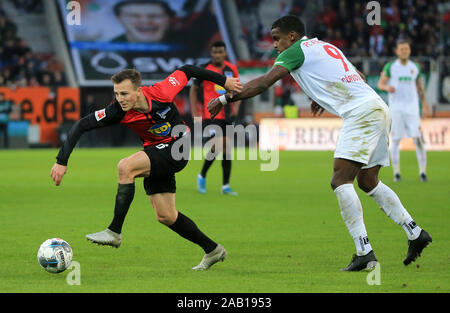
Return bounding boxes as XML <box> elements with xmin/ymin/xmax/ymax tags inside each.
<box><xmin>169</xmin><ymin>212</ymin><xmax>217</xmax><ymax>253</ymax></box>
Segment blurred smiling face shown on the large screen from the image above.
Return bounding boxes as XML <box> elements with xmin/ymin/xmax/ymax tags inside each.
<box><xmin>118</xmin><ymin>3</ymin><xmax>170</xmax><ymax>42</ymax></box>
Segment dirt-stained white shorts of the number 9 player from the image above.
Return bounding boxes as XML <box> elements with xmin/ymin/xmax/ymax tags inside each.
<box><xmin>334</xmin><ymin>99</ymin><xmax>392</xmax><ymax>169</ymax></box>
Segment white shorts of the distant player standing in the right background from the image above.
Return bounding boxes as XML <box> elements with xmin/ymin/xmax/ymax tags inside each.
<box><xmin>391</xmin><ymin>111</ymin><xmax>421</xmax><ymax>140</ymax></box>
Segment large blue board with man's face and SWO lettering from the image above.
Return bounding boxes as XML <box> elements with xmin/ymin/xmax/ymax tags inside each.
<box><xmin>58</xmin><ymin>0</ymin><xmax>235</xmax><ymax>86</ymax></box>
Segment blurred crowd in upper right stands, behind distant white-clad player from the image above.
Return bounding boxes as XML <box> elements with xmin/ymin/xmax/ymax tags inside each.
<box><xmin>315</xmin><ymin>0</ymin><xmax>444</xmax><ymax>57</ymax></box>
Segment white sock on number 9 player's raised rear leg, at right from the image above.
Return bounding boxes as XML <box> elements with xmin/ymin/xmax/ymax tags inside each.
<box><xmin>367</xmin><ymin>180</ymin><xmax>422</xmax><ymax>240</ymax></box>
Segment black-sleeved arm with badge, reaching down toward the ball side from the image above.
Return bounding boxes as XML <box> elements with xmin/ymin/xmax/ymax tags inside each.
<box><xmin>50</xmin><ymin>101</ymin><xmax>124</xmax><ymax>186</ymax></box>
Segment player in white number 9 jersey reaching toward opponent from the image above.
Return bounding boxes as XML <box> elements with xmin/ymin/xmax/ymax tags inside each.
<box><xmin>208</xmin><ymin>16</ymin><xmax>432</xmax><ymax>271</ymax></box>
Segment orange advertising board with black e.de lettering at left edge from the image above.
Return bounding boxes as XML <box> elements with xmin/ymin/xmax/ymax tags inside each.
<box><xmin>0</xmin><ymin>87</ymin><xmax>80</xmax><ymax>146</ymax></box>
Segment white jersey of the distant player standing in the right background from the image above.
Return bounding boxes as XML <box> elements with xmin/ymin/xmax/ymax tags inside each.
<box><xmin>383</xmin><ymin>59</ymin><xmax>420</xmax><ymax>116</ymax></box>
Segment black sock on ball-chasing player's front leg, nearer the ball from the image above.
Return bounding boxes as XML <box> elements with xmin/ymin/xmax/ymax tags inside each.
<box><xmin>108</xmin><ymin>183</ymin><xmax>134</xmax><ymax>234</ymax></box>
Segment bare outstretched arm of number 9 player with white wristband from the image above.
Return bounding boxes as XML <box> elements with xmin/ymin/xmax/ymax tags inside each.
<box><xmin>208</xmin><ymin>65</ymin><xmax>289</xmax><ymax>118</ymax></box>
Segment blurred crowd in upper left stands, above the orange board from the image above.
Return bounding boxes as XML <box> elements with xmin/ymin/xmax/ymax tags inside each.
<box><xmin>0</xmin><ymin>0</ymin><xmax>66</xmax><ymax>88</ymax></box>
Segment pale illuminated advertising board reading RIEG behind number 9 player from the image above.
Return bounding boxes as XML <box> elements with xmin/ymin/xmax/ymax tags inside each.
<box><xmin>259</xmin><ymin>118</ymin><xmax>450</xmax><ymax>151</ymax></box>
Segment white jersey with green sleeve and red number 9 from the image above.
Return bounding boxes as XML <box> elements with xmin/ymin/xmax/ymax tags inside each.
<box><xmin>274</xmin><ymin>37</ymin><xmax>381</xmax><ymax>117</ymax></box>
